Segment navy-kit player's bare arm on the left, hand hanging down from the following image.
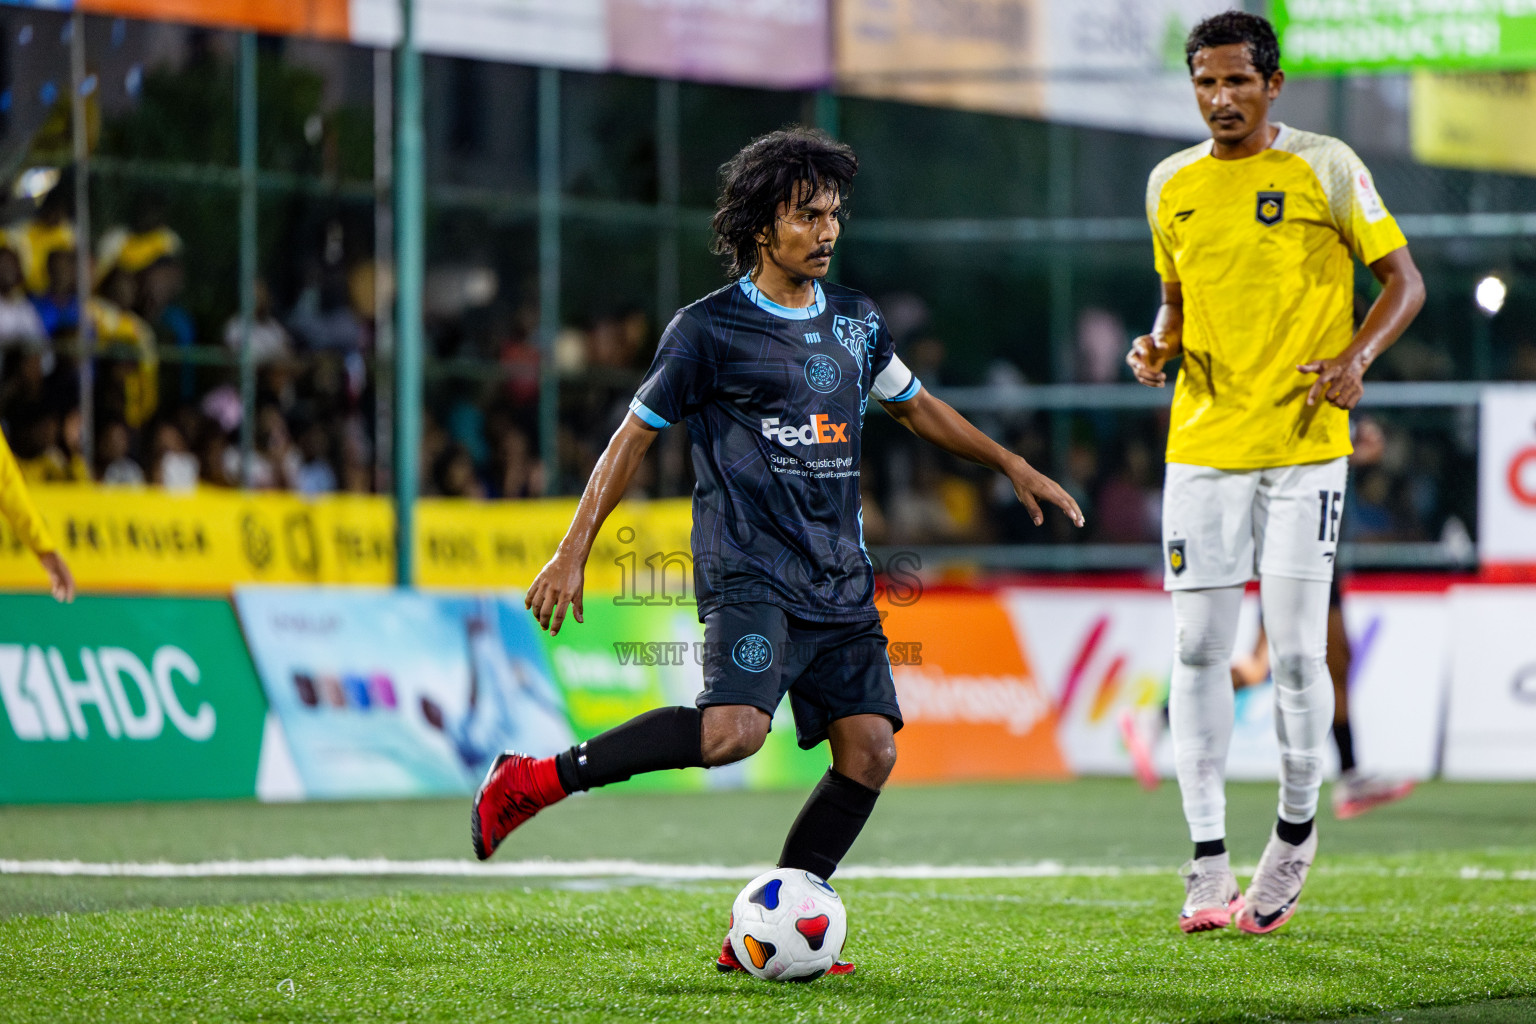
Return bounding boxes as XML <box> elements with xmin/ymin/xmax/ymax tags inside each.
<box><xmin>522</xmin><ymin>413</ymin><xmax>659</xmax><ymax>636</ymax></box>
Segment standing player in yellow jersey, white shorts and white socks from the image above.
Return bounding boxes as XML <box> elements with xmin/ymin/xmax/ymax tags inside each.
<box><xmin>1126</xmin><ymin>11</ymin><xmax>1424</xmax><ymax>933</ymax></box>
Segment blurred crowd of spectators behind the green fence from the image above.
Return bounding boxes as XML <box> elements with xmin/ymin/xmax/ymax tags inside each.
<box><xmin>0</xmin><ymin>189</ymin><xmax>1499</xmax><ymax>545</ymax></box>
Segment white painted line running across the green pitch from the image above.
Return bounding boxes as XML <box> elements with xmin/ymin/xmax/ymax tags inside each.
<box><xmin>0</xmin><ymin>857</ymin><xmax>1536</xmax><ymax>881</ymax></box>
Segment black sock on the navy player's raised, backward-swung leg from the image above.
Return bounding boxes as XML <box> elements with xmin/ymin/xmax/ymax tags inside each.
<box><xmin>554</xmin><ymin>708</ymin><xmax>703</xmax><ymax>792</ymax></box>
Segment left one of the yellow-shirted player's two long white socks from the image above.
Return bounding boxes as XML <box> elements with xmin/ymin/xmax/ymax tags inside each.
<box><xmin>1167</xmin><ymin>586</ymin><xmax>1243</xmax><ymax>843</ymax></box>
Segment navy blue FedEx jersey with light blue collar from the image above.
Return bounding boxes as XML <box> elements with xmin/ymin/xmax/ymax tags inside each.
<box><xmin>630</xmin><ymin>278</ymin><xmax>922</xmax><ymax>622</ymax></box>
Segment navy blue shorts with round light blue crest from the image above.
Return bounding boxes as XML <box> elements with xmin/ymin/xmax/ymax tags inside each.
<box><xmin>694</xmin><ymin>605</ymin><xmax>902</xmax><ymax>751</ymax></box>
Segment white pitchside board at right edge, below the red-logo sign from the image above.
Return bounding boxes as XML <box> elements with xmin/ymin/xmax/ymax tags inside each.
<box><xmin>1444</xmin><ymin>586</ymin><xmax>1536</xmax><ymax>778</ymax></box>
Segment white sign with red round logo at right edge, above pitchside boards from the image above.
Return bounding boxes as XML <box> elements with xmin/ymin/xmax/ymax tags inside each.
<box><xmin>1478</xmin><ymin>384</ymin><xmax>1536</xmax><ymax>565</ymax></box>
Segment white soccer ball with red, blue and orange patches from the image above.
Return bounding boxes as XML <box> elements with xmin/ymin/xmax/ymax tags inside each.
<box><xmin>731</xmin><ymin>867</ymin><xmax>848</xmax><ymax>981</ymax></box>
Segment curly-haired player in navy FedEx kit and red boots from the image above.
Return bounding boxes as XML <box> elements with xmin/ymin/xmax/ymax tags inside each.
<box><xmin>470</xmin><ymin>127</ymin><xmax>1083</xmax><ymax>973</ymax></box>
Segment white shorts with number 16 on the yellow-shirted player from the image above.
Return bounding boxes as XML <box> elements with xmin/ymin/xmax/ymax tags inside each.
<box><xmin>1163</xmin><ymin>457</ymin><xmax>1349</xmax><ymax>590</ymax></box>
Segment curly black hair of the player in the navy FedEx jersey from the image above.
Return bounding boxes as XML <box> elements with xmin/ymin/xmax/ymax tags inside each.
<box><xmin>713</xmin><ymin>124</ymin><xmax>859</xmax><ymax>278</ymax></box>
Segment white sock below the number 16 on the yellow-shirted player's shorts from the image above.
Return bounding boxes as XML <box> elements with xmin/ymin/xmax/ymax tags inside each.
<box><xmin>1260</xmin><ymin>576</ymin><xmax>1333</xmax><ymax>824</ymax></box>
